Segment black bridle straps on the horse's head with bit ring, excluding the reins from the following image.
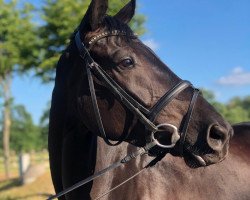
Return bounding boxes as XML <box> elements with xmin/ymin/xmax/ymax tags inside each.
<box><xmin>75</xmin><ymin>30</ymin><xmax>199</xmax><ymax>153</ymax></box>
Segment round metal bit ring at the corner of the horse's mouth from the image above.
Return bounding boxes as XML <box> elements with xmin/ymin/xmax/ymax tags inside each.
<box><xmin>151</xmin><ymin>123</ymin><xmax>180</xmax><ymax>148</ymax></box>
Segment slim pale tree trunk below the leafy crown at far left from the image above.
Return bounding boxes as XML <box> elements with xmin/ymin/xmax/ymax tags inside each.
<box><xmin>1</xmin><ymin>75</ymin><xmax>12</xmax><ymax>179</ymax></box>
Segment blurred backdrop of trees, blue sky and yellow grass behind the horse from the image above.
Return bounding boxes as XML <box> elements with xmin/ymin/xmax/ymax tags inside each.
<box><xmin>0</xmin><ymin>0</ymin><xmax>250</xmax><ymax>200</ymax></box>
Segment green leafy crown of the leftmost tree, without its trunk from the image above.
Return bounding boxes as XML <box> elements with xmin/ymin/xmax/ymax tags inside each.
<box><xmin>0</xmin><ymin>0</ymin><xmax>38</xmax><ymax>79</ymax></box>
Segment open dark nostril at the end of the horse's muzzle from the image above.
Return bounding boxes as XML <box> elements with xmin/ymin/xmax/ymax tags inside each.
<box><xmin>207</xmin><ymin>124</ymin><xmax>227</xmax><ymax>150</ymax></box>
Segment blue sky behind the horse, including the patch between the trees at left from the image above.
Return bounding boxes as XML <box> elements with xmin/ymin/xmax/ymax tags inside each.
<box><xmin>12</xmin><ymin>0</ymin><xmax>250</xmax><ymax>123</ymax></box>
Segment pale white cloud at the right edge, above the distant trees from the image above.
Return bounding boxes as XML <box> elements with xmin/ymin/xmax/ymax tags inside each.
<box><xmin>218</xmin><ymin>67</ymin><xmax>250</xmax><ymax>86</ymax></box>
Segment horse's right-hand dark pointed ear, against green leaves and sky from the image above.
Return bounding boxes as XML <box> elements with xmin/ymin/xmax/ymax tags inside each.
<box><xmin>114</xmin><ymin>0</ymin><xmax>136</xmax><ymax>24</ymax></box>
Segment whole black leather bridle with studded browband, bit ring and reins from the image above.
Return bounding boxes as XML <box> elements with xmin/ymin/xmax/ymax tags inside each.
<box><xmin>48</xmin><ymin>30</ymin><xmax>199</xmax><ymax>200</ymax></box>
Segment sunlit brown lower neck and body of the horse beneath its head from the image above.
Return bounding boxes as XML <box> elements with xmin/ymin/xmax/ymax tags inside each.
<box><xmin>91</xmin><ymin>138</ymin><xmax>250</xmax><ymax>200</ymax></box>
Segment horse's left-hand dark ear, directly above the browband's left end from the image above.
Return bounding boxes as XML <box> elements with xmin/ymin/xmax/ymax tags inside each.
<box><xmin>81</xmin><ymin>0</ymin><xmax>108</xmax><ymax>31</ymax></box>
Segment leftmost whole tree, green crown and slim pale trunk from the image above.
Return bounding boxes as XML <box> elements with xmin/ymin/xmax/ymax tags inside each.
<box><xmin>0</xmin><ymin>0</ymin><xmax>38</xmax><ymax>178</ymax></box>
